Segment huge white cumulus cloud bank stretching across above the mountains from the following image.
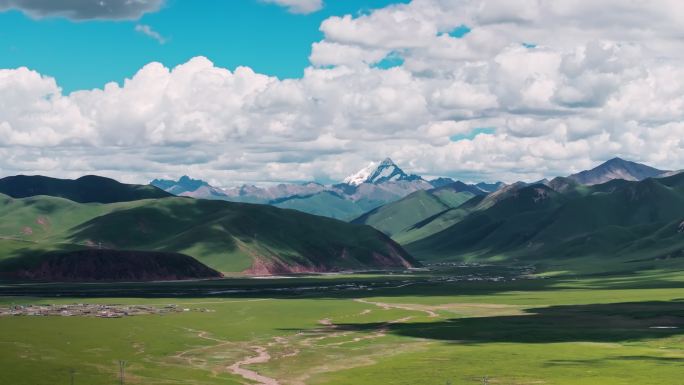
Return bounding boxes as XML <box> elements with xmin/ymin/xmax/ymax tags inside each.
<box><xmin>0</xmin><ymin>0</ymin><xmax>684</xmax><ymax>185</ymax></box>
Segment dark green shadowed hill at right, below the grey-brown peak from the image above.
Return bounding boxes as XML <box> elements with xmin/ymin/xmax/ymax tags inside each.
<box><xmin>401</xmin><ymin>175</ymin><xmax>684</xmax><ymax>271</ymax></box>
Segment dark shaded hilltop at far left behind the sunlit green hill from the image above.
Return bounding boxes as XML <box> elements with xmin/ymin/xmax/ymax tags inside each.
<box><xmin>0</xmin><ymin>175</ymin><xmax>171</xmax><ymax>203</ymax></box>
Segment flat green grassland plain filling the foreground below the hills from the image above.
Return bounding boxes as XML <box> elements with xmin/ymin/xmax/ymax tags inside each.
<box><xmin>0</xmin><ymin>271</ymin><xmax>684</xmax><ymax>385</ymax></box>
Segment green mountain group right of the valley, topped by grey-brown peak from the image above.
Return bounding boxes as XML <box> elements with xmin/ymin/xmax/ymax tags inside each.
<box><xmin>353</xmin><ymin>158</ymin><xmax>684</xmax><ymax>273</ymax></box>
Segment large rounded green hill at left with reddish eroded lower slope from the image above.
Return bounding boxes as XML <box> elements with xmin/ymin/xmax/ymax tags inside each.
<box><xmin>0</xmin><ymin>195</ymin><xmax>416</xmax><ymax>274</ymax></box>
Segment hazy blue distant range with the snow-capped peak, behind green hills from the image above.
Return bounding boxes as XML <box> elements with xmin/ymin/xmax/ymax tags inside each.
<box><xmin>151</xmin><ymin>158</ymin><xmax>504</xmax><ymax>220</ymax></box>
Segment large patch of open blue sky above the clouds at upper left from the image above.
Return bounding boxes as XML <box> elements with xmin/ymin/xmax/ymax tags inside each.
<box><xmin>0</xmin><ymin>0</ymin><xmax>401</xmax><ymax>92</ymax></box>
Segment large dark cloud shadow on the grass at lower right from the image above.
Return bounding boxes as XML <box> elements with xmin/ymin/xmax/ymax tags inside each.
<box><xmin>316</xmin><ymin>301</ymin><xmax>684</xmax><ymax>344</ymax></box>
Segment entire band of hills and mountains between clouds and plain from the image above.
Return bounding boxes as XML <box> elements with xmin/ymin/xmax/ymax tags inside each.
<box><xmin>0</xmin><ymin>158</ymin><xmax>684</xmax><ymax>280</ymax></box>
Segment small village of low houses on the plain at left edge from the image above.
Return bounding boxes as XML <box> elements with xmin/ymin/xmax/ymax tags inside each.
<box><xmin>0</xmin><ymin>304</ymin><xmax>213</xmax><ymax>318</ymax></box>
